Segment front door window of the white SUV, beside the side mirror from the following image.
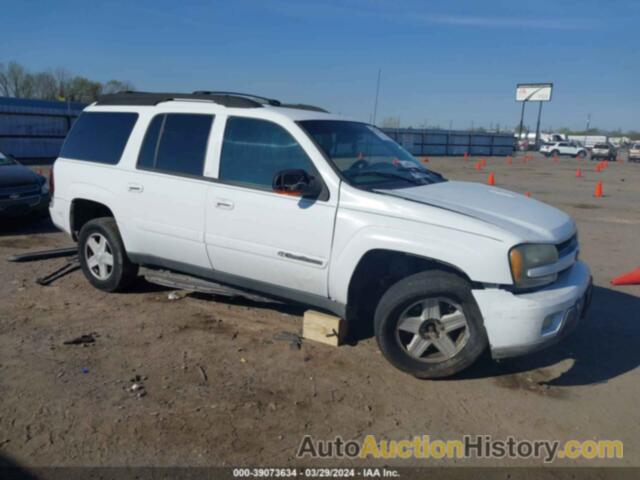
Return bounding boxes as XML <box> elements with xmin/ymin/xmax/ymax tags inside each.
<box><xmin>219</xmin><ymin>117</ymin><xmax>317</xmax><ymax>191</ymax></box>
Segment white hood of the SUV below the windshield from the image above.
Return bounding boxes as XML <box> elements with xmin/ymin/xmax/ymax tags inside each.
<box><xmin>383</xmin><ymin>181</ymin><xmax>575</xmax><ymax>243</ymax></box>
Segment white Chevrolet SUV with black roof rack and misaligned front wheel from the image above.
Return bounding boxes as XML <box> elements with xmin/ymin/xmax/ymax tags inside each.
<box><xmin>50</xmin><ymin>92</ymin><xmax>591</xmax><ymax>378</ymax></box>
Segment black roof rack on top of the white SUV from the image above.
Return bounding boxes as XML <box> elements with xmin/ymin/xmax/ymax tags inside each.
<box><xmin>97</xmin><ymin>90</ymin><xmax>327</xmax><ymax>113</ymax></box>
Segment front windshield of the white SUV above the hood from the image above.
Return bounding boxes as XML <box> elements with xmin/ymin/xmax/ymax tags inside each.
<box><xmin>300</xmin><ymin>120</ymin><xmax>444</xmax><ymax>188</ymax></box>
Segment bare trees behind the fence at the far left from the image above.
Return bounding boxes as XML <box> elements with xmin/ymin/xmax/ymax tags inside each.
<box><xmin>0</xmin><ymin>62</ymin><xmax>134</xmax><ymax>103</ymax></box>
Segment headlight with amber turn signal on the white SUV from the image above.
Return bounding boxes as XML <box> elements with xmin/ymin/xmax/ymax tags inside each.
<box><xmin>509</xmin><ymin>244</ymin><xmax>558</xmax><ymax>288</ymax></box>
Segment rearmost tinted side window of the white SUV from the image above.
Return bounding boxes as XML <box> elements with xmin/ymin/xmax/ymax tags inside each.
<box><xmin>60</xmin><ymin>112</ymin><xmax>138</xmax><ymax>165</ymax></box>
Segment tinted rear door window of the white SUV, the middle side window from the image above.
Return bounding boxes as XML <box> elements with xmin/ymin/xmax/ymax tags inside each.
<box><xmin>138</xmin><ymin>113</ymin><xmax>213</xmax><ymax>176</ymax></box>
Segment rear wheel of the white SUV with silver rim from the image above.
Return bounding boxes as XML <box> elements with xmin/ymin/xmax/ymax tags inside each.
<box><xmin>78</xmin><ymin>217</ymin><xmax>138</xmax><ymax>292</ymax></box>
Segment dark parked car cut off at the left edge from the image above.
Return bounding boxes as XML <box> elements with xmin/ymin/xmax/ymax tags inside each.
<box><xmin>0</xmin><ymin>152</ymin><xmax>49</xmax><ymax>218</ymax></box>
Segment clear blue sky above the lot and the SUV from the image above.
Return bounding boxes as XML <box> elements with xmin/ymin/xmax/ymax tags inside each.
<box><xmin>0</xmin><ymin>0</ymin><xmax>640</xmax><ymax>130</ymax></box>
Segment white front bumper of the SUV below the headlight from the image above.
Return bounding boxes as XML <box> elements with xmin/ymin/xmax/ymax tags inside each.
<box><xmin>473</xmin><ymin>262</ymin><xmax>592</xmax><ymax>358</ymax></box>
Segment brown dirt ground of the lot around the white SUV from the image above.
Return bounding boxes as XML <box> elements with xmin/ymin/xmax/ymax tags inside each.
<box><xmin>0</xmin><ymin>156</ymin><xmax>640</xmax><ymax>466</ymax></box>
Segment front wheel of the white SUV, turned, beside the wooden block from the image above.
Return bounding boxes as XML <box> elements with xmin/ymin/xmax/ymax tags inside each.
<box><xmin>374</xmin><ymin>270</ymin><xmax>488</xmax><ymax>378</ymax></box>
